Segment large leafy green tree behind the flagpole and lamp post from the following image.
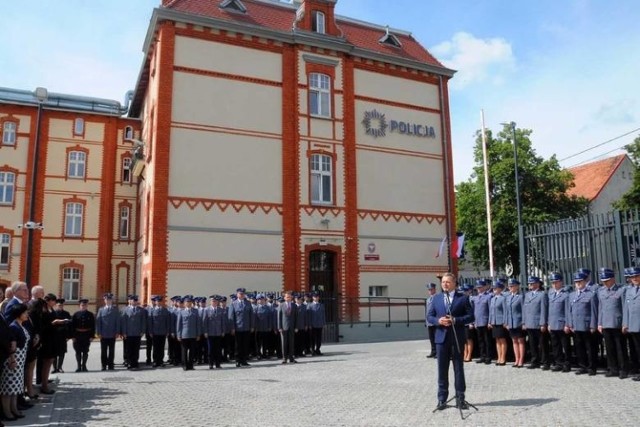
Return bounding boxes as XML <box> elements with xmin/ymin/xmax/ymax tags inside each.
<box><xmin>456</xmin><ymin>125</ymin><xmax>588</xmax><ymax>275</ymax></box>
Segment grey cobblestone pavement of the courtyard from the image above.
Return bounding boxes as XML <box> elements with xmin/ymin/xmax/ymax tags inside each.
<box><xmin>12</xmin><ymin>341</ymin><xmax>640</xmax><ymax>427</ymax></box>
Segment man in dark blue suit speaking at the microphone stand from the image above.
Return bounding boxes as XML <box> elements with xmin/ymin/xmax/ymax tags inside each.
<box><xmin>427</xmin><ymin>273</ymin><xmax>474</xmax><ymax>410</ymax></box>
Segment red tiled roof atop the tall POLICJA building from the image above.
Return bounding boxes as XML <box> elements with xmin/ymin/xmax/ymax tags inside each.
<box><xmin>162</xmin><ymin>0</ymin><xmax>442</xmax><ymax>66</ymax></box>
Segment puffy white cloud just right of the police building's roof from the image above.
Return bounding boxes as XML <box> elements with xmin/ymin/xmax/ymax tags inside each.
<box><xmin>430</xmin><ymin>32</ymin><xmax>516</xmax><ymax>89</ymax></box>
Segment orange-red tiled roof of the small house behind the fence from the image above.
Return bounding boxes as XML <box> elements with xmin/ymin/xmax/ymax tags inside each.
<box><xmin>568</xmin><ymin>154</ymin><xmax>627</xmax><ymax>201</ymax></box>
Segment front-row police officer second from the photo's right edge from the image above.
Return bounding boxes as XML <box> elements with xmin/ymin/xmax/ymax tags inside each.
<box><xmin>598</xmin><ymin>268</ymin><xmax>629</xmax><ymax>379</ymax></box>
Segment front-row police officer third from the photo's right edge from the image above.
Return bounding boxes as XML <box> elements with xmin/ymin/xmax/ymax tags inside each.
<box><xmin>564</xmin><ymin>272</ymin><xmax>598</xmax><ymax>376</ymax></box>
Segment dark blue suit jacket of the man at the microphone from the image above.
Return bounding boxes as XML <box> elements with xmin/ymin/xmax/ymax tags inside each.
<box><xmin>427</xmin><ymin>291</ymin><xmax>474</xmax><ymax>348</ymax></box>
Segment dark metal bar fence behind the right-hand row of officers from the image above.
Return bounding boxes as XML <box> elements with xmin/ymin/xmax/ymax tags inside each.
<box><xmin>525</xmin><ymin>209</ymin><xmax>640</xmax><ymax>283</ymax></box>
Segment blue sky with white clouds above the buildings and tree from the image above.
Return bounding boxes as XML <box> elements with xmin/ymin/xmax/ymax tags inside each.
<box><xmin>0</xmin><ymin>0</ymin><xmax>640</xmax><ymax>183</ymax></box>
